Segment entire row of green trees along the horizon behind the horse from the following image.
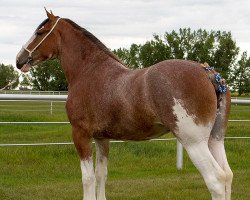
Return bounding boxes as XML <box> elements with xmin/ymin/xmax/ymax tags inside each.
<box><xmin>0</xmin><ymin>28</ymin><xmax>250</xmax><ymax>95</ymax></box>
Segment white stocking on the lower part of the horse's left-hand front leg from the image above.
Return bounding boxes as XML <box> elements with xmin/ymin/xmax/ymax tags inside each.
<box><xmin>81</xmin><ymin>158</ymin><xmax>96</xmax><ymax>200</ymax></box>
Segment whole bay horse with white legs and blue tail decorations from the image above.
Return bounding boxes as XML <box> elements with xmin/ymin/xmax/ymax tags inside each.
<box><xmin>16</xmin><ymin>10</ymin><xmax>233</xmax><ymax>200</ymax></box>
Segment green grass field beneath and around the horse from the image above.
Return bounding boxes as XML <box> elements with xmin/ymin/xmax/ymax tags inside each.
<box><xmin>0</xmin><ymin>102</ymin><xmax>250</xmax><ymax>200</ymax></box>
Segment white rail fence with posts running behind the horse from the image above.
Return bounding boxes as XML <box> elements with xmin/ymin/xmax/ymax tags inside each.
<box><xmin>0</xmin><ymin>94</ymin><xmax>250</xmax><ymax>170</ymax></box>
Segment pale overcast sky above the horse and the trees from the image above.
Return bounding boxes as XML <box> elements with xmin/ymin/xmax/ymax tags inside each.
<box><xmin>0</xmin><ymin>0</ymin><xmax>250</xmax><ymax>66</ymax></box>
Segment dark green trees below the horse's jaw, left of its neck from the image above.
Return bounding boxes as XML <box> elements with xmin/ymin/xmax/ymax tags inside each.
<box><xmin>30</xmin><ymin>59</ymin><xmax>68</xmax><ymax>91</ymax></box>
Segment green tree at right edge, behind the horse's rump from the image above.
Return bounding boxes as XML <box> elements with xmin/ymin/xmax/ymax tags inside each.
<box><xmin>231</xmin><ymin>52</ymin><xmax>250</xmax><ymax>96</ymax></box>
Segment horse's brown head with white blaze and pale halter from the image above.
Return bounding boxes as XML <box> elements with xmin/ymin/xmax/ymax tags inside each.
<box><xmin>16</xmin><ymin>9</ymin><xmax>60</xmax><ymax>72</ymax></box>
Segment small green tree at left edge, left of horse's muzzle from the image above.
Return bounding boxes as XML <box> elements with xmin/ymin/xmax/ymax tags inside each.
<box><xmin>0</xmin><ymin>64</ymin><xmax>19</xmax><ymax>90</ymax></box>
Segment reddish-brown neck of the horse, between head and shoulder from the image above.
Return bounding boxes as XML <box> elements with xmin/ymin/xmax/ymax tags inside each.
<box><xmin>60</xmin><ymin>24</ymin><xmax>127</xmax><ymax>85</ymax></box>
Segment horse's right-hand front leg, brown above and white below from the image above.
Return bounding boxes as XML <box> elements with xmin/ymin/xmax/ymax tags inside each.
<box><xmin>95</xmin><ymin>139</ymin><xmax>109</xmax><ymax>200</ymax></box>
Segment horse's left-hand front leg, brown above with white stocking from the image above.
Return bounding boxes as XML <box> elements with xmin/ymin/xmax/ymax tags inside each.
<box><xmin>73</xmin><ymin>127</ymin><xmax>96</xmax><ymax>200</ymax></box>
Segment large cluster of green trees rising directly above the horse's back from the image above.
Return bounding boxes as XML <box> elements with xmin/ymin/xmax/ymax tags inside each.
<box><xmin>114</xmin><ymin>28</ymin><xmax>239</xmax><ymax>79</ymax></box>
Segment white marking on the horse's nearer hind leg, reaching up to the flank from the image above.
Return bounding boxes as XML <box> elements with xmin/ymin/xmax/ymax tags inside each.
<box><xmin>173</xmin><ymin>99</ymin><xmax>226</xmax><ymax>200</ymax></box>
